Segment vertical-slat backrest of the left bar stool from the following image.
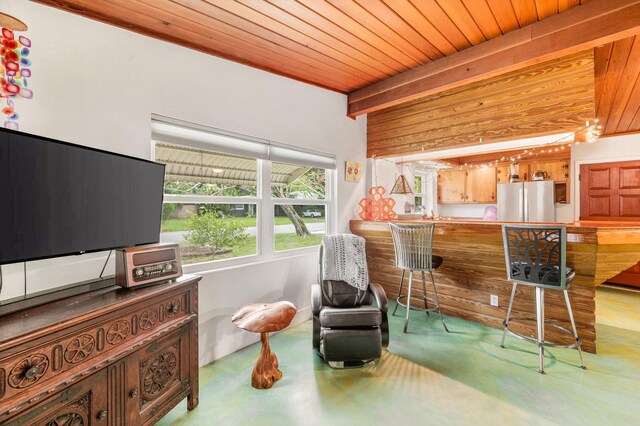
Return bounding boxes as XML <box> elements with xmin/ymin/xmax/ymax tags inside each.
<box><xmin>389</xmin><ymin>222</ymin><xmax>435</xmax><ymax>271</ymax></box>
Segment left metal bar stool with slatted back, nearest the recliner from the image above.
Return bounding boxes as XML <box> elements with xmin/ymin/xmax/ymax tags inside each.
<box><xmin>389</xmin><ymin>223</ymin><xmax>449</xmax><ymax>333</ymax></box>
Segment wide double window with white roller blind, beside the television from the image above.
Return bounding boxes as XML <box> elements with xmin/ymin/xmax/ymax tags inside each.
<box><xmin>152</xmin><ymin>120</ymin><xmax>336</xmax><ymax>265</ymax></box>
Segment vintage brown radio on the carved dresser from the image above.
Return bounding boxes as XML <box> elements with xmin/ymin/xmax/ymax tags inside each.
<box><xmin>116</xmin><ymin>244</ymin><xmax>182</xmax><ymax>288</ymax></box>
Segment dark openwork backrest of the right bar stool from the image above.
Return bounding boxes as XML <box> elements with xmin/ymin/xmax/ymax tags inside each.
<box><xmin>502</xmin><ymin>225</ymin><xmax>567</xmax><ymax>290</ymax></box>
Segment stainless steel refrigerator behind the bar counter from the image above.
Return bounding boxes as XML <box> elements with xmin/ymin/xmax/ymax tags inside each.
<box><xmin>498</xmin><ymin>180</ymin><xmax>556</xmax><ymax>222</ymax></box>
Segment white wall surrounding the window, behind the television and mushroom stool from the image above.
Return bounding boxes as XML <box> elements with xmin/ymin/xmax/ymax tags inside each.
<box><xmin>3</xmin><ymin>2</ymin><xmax>366</xmax><ymax>364</ymax></box>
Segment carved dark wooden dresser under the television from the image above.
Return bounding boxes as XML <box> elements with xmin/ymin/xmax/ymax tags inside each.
<box><xmin>0</xmin><ymin>276</ymin><xmax>200</xmax><ymax>426</ymax></box>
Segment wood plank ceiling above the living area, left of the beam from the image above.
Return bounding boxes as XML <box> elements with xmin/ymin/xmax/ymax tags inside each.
<box><xmin>36</xmin><ymin>0</ymin><xmax>587</xmax><ymax>93</ymax></box>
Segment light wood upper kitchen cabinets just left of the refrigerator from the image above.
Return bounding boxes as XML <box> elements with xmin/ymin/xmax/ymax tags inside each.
<box><xmin>438</xmin><ymin>167</ymin><xmax>496</xmax><ymax>204</ymax></box>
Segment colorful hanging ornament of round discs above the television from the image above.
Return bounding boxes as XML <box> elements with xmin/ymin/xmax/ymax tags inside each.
<box><xmin>0</xmin><ymin>13</ymin><xmax>33</xmax><ymax>130</ymax></box>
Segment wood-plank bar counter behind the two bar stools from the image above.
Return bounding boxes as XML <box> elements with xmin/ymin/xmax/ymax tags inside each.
<box><xmin>350</xmin><ymin>219</ymin><xmax>640</xmax><ymax>353</ymax></box>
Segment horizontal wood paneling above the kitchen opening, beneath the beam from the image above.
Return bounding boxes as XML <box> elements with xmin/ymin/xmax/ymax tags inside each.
<box><xmin>367</xmin><ymin>51</ymin><xmax>595</xmax><ymax>157</ymax></box>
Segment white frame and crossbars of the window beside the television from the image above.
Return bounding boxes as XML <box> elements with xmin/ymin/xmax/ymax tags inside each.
<box><xmin>151</xmin><ymin>121</ymin><xmax>337</xmax><ymax>273</ymax></box>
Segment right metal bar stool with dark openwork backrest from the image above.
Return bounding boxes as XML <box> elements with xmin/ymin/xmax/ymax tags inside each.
<box><xmin>500</xmin><ymin>225</ymin><xmax>586</xmax><ymax>374</ymax></box>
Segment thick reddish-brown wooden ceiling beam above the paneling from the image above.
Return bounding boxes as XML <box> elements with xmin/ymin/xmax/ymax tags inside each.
<box><xmin>347</xmin><ymin>0</ymin><xmax>640</xmax><ymax>118</ymax></box>
